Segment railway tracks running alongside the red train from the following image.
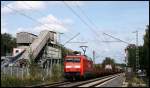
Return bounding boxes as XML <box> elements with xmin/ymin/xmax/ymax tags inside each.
<box><xmin>30</xmin><ymin>73</ymin><xmax>122</xmax><ymax>87</ymax></box>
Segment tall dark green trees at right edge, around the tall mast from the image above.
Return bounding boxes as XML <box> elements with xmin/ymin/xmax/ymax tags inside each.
<box><xmin>127</xmin><ymin>25</ymin><xmax>149</xmax><ymax>74</ymax></box>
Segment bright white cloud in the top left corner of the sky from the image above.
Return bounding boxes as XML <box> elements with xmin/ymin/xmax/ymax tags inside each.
<box><xmin>1</xmin><ymin>1</ymin><xmax>46</xmax><ymax>14</ymax></box>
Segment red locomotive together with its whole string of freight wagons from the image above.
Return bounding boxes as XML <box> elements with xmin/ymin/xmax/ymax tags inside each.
<box><xmin>64</xmin><ymin>55</ymin><xmax>122</xmax><ymax>80</ymax></box>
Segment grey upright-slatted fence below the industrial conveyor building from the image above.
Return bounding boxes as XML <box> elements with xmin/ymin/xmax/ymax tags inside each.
<box><xmin>1</xmin><ymin>67</ymin><xmax>52</xmax><ymax>79</ymax></box>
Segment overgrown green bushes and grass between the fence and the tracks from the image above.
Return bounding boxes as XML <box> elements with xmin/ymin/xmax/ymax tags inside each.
<box><xmin>1</xmin><ymin>59</ymin><xmax>63</xmax><ymax>87</ymax></box>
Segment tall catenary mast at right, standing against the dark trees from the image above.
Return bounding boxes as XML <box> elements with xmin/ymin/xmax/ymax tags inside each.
<box><xmin>133</xmin><ymin>31</ymin><xmax>139</xmax><ymax>71</ymax></box>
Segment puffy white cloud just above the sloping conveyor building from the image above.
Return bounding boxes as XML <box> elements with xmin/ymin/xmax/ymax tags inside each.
<box><xmin>17</xmin><ymin>14</ymin><xmax>73</xmax><ymax>33</ymax></box>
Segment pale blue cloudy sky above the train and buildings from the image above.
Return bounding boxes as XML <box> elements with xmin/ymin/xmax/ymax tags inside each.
<box><xmin>1</xmin><ymin>1</ymin><xmax>149</xmax><ymax>63</ymax></box>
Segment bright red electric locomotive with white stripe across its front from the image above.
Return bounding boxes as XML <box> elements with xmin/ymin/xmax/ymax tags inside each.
<box><xmin>64</xmin><ymin>55</ymin><xmax>93</xmax><ymax>80</ymax></box>
